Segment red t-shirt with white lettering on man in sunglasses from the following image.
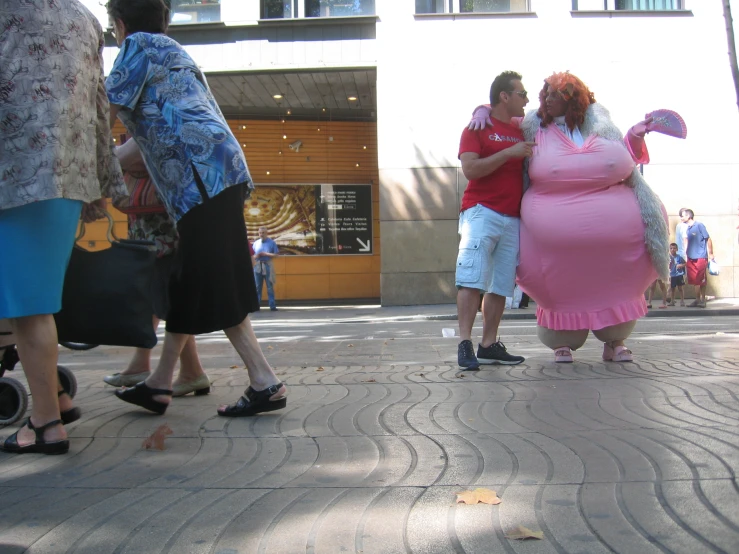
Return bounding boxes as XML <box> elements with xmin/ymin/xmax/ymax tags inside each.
<box><xmin>459</xmin><ymin>117</ymin><xmax>524</xmax><ymax>217</ymax></box>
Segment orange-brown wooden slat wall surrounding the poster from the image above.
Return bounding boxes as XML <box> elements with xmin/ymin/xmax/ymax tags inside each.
<box><xmin>90</xmin><ymin>116</ymin><xmax>380</xmax><ymax>303</ymax></box>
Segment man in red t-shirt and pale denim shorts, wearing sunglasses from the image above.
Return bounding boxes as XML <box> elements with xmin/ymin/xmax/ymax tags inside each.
<box><xmin>456</xmin><ymin>71</ymin><xmax>534</xmax><ymax>370</ymax></box>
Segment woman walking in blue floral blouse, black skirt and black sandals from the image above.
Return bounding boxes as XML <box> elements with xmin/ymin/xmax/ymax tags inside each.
<box><xmin>106</xmin><ymin>0</ymin><xmax>287</xmax><ymax>417</ymax></box>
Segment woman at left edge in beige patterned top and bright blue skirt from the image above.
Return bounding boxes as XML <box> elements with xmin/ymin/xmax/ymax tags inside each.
<box><xmin>0</xmin><ymin>0</ymin><xmax>123</xmax><ymax>454</ymax></box>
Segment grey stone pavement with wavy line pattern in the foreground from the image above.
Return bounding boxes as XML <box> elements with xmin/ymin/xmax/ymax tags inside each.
<box><xmin>0</xmin><ymin>314</ymin><xmax>739</xmax><ymax>554</ymax></box>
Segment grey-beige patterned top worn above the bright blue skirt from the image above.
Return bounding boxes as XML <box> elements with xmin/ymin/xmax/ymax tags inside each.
<box><xmin>0</xmin><ymin>0</ymin><xmax>123</xmax><ymax>210</ymax></box>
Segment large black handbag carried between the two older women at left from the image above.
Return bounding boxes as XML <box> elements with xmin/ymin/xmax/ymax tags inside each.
<box><xmin>54</xmin><ymin>212</ymin><xmax>157</xmax><ymax>348</ymax></box>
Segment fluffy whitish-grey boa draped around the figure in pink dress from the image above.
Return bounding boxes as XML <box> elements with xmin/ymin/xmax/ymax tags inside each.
<box><xmin>521</xmin><ymin>102</ymin><xmax>670</xmax><ymax>280</ymax></box>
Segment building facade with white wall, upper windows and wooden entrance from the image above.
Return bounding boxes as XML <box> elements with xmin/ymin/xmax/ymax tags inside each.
<box><xmin>82</xmin><ymin>0</ymin><xmax>739</xmax><ymax>305</ymax></box>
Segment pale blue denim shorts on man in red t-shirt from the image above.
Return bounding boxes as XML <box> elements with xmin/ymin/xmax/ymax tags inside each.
<box><xmin>455</xmin><ymin>204</ymin><xmax>520</xmax><ymax>296</ymax></box>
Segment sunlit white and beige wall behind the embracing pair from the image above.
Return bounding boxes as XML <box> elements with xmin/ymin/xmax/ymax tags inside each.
<box><xmin>376</xmin><ymin>0</ymin><xmax>739</xmax><ymax>305</ymax></box>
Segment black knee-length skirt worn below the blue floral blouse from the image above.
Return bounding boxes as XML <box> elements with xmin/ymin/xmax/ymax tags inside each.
<box><xmin>166</xmin><ymin>185</ymin><xmax>259</xmax><ymax>335</ymax></box>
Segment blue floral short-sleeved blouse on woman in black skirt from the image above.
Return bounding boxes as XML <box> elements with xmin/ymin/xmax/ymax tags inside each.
<box><xmin>106</xmin><ymin>33</ymin><xmax>253</xmax><ymax>221</ymax></box>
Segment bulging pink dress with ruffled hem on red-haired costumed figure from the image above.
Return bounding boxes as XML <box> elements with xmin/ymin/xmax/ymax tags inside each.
<box><xmin>517</xmin><ymin>124</ymin><xmax>657</xmax><ymax>330</ymax></box>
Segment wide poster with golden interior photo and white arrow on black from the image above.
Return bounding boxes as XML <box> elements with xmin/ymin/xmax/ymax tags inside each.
<box><xmin>244</xmin><ymin>184</ymin><xmax>372</xmax><ymax>256</ymax></box>
